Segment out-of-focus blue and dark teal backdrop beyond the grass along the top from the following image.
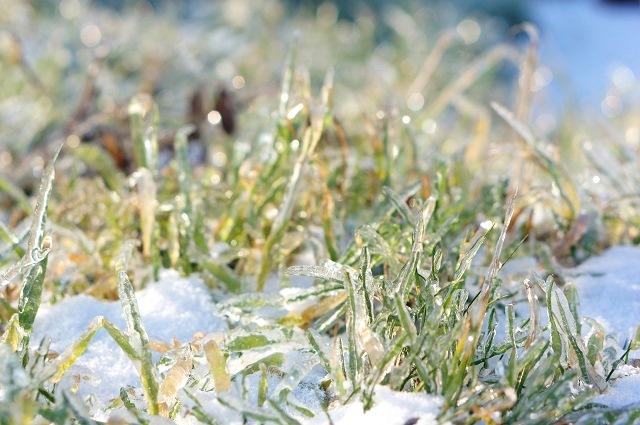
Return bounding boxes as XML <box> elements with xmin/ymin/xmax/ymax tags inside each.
<box><xmin>82</xmin><ymin>0</ymin><xmax>640</xmax><ymax>116</ymax></box>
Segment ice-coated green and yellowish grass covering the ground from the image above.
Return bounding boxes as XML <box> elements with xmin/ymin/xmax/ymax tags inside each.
<box><xmin>0</xmin><ymin>3</ymin><xmax>640</xmax><ymax>424</ymax></box>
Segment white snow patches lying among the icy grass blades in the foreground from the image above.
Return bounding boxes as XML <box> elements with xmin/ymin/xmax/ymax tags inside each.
<box><xmin>32</xmin><ymin>246</ymin><xmax>640</xmax><ymax>425</ymax></box>
